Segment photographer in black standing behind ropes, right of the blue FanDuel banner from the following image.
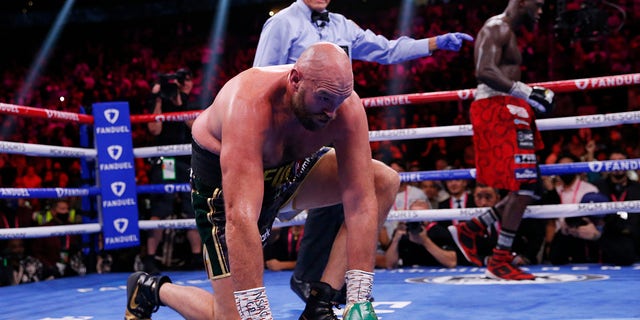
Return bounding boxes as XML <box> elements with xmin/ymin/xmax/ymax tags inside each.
<box><xmin>142</xmin><ymin>69</ymin><xmax>202</xmax><ymax>273</ymax></box>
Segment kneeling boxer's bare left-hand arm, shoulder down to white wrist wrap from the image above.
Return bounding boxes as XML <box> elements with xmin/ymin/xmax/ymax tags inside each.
<box><xmin>220</xmin><ymin>94</ymin><xmax>269</xmax><ymax>291</ymax></box>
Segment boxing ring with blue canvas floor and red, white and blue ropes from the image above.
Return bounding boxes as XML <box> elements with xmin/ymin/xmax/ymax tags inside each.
<box><xmin>0</xmin><ymin>74</ymin><xmax>640</xmax><ymax>319</ymax></box>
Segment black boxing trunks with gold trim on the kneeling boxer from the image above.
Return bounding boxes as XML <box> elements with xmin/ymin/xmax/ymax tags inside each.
<box><xmin>190</xmin><ymin>141</ymin><xmax>331</xmax><ymax>279</ymax></box>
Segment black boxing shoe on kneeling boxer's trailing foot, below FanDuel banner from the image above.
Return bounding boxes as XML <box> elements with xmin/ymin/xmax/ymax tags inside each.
<box><xmin>124</xmin><ymin>271</ymin><xmax>171</xmax><ymax>320</ymax></box>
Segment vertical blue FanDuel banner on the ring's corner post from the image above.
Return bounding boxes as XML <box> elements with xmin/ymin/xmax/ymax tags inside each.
<box><xmin>93</xmin><ymin>102</ymin><xmax>140</xmax><ymax>250</ymax></box>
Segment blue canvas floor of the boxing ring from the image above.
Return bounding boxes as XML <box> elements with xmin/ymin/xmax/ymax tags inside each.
<box><xmin>0</xmin><ymin>264</ymin><xmax>640</xmax><ymax>320</ymax></box>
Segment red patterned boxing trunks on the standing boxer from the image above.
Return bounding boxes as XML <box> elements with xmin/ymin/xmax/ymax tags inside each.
<box><xmin>470</xmin><ymin>95</ymin><xmax>544</xmax><ymax>191</ymax></box>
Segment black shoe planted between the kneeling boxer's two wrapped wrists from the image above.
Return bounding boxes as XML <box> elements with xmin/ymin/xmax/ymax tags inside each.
<box><xmin>298</xmin><ymin>282</ymin><xmax>338</xmax><ymax>320</ymax></box>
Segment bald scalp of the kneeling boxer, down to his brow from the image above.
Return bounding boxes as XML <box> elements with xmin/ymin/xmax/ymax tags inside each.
<box><xmin>293</xmin><ymin>42</ymin><xmax>353</xmax><ymax>96</ymax></box>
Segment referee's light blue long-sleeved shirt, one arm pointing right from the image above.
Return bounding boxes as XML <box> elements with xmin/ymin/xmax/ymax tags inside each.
<box><xmin>253</xmin><ymin>0</ymin><xmax>431</xmax><ymax>67</ymax></box>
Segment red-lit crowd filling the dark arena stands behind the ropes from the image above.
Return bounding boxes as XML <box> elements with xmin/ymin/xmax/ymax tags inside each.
<box><xmin>0</xmin><ymin>0</ymin><xmax>640</xmax><ymax>281</ymax></box>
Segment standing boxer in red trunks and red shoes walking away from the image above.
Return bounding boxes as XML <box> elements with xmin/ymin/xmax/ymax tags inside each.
<box><xmin>449</xmin><ymin>0</ymin><xmax>553</xmax><ymax>280</ymax></box>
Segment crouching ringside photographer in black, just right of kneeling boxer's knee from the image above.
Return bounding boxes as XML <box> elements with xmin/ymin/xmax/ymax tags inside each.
<box><xmin>385</xmin><ymin>200</ymin><xmax>457</xmax><ymax>269</ymax></box>
